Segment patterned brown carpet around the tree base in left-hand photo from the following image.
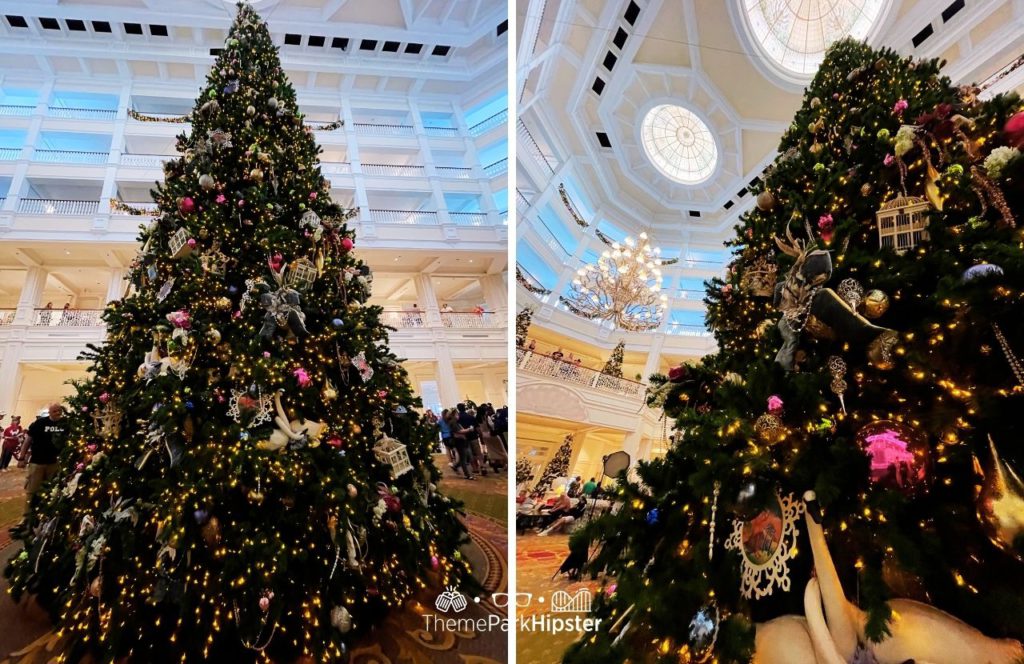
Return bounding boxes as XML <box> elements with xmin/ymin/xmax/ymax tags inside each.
<box><xmin>0</xmin><ymin>461</ymin><xmax>509</xmax><ymax>664</ymax></box>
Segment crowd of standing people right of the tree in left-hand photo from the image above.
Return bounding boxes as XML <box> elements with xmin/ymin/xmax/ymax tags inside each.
<box><xmin>437</xmin><ymin>404</ymin><xmax>509</xmax><ymax>480</ymax></box>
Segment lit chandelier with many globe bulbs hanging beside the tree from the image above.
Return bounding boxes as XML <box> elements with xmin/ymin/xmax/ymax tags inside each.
<box><xmin>560</xmin><ymin>233</ymin><xmax>668</xmax><ymax>331</ymax></box>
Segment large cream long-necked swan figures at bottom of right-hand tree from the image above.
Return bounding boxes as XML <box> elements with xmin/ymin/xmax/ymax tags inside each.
<box><xmin>754</xmin><ymin>491</ymin><xmax>1024</xmax><ymax>664</ymax></box>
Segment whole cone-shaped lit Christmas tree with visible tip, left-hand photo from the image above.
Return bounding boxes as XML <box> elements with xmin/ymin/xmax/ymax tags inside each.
<box><xmin>6</xmin><ymin>3</ymin><xmax>467</xmax><ymax>662</ymax></box>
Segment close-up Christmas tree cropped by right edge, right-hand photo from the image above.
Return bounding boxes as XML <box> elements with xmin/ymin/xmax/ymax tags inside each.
<box><xmin>565</xmin><ymin>40</ymin><xmax>1024</xmax><ymax>664</ymax></box>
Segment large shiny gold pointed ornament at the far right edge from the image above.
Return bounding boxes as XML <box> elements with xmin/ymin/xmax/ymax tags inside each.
<box><xmin>975</xmin><ymin>435</ymin><xmax>1024</xmax><ymax>559</ymax></box>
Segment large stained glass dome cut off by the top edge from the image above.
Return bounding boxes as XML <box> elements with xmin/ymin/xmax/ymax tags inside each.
<box><xmin>741</xmin><ymin>0</ymin><xmax>887</xmax><ymax>77</ymax></box>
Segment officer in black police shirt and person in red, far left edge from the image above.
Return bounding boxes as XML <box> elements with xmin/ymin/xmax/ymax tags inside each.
<box><xmin>0</xmin><ymin>404</ymin><xmax>68</xmax><ymax>514</ymax></box>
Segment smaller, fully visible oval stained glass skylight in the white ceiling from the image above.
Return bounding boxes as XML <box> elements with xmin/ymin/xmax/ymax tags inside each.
<box><xmin>640</xmin><ymin>103</ymin><xmax>718</xmax><ymax>184</ymax></box>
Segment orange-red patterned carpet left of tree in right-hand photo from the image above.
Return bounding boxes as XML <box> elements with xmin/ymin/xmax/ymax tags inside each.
<box><xmin>515</xmin><ymin>535</ymin><xmax>601</xmax><ymax>664</ymax></box>
